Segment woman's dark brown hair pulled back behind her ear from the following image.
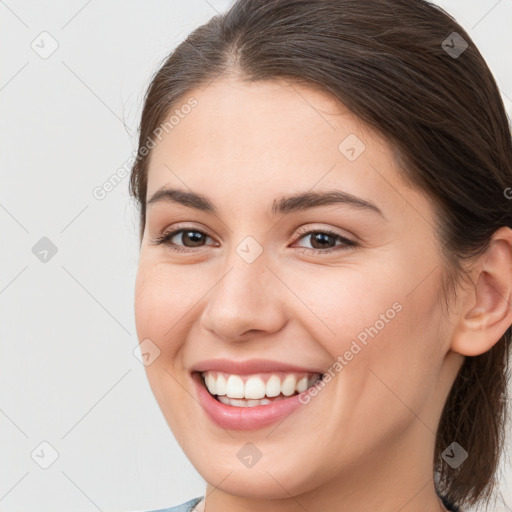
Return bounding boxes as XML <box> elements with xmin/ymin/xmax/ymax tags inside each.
<box><xmin>130</xmin><ymin>0</ymin><xmax>512</xmax><ymax>506</ymax></box>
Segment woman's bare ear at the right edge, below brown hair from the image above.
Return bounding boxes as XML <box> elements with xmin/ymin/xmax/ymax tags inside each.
<box><xmin>450</xmin><ymin>227</ymin><xmax>512</xmax><ymax>356</ymax></box>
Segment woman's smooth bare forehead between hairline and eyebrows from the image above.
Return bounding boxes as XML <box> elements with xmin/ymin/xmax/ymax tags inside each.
<box><xmin>147</xmin><ymin>77</ymin><xmax>418</xmax><ymax>218</ymax></box>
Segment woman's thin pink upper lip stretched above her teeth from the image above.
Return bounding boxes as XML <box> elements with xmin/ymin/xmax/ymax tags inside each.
<box><xmin>191</xmin><ymin>359</ymin><xmax>323</xmax><ymax>375</ymax></box>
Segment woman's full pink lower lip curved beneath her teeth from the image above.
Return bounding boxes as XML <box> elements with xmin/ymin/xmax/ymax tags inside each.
<box><xmin>192</xmin><ymin>372</ymin><xmax>311</xmax><ymax>430</ymax></box>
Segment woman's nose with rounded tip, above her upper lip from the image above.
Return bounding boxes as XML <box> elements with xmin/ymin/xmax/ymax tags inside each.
<box><xmin>200</xmin><ymin>253</ymin><xmax>290</xmax><ymax>341</ymax></box>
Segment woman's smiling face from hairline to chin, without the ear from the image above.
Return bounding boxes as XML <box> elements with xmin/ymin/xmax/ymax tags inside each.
<box><xmin>135</xmin><ymin>78</ymin><xmax>462</xmax><ymax>504</ymax></box>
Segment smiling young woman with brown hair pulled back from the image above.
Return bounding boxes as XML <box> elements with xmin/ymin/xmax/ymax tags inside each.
<box><xmin>130</xmin><ymin>0</ymin><xmax>512</xmax><ymax>512</ymax></box>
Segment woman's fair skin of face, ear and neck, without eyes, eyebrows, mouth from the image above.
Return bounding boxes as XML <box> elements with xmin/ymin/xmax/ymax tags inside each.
<box><xmin>135</xmin><ymin>76</ymin><xmax>512</xmax><ymax>512</ymax></box>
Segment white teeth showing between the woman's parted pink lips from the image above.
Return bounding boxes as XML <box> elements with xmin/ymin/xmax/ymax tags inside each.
<box><xmin>200</xmin><ymin>371</ymin><xmax>323</xmax><ymax>407</ymax></box>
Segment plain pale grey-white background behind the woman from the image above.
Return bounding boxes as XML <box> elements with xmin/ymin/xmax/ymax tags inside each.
<box><xmin>0</xmin><ymin>0</ymin><xmax>512</xmax><ymax>512</ymax></box>
